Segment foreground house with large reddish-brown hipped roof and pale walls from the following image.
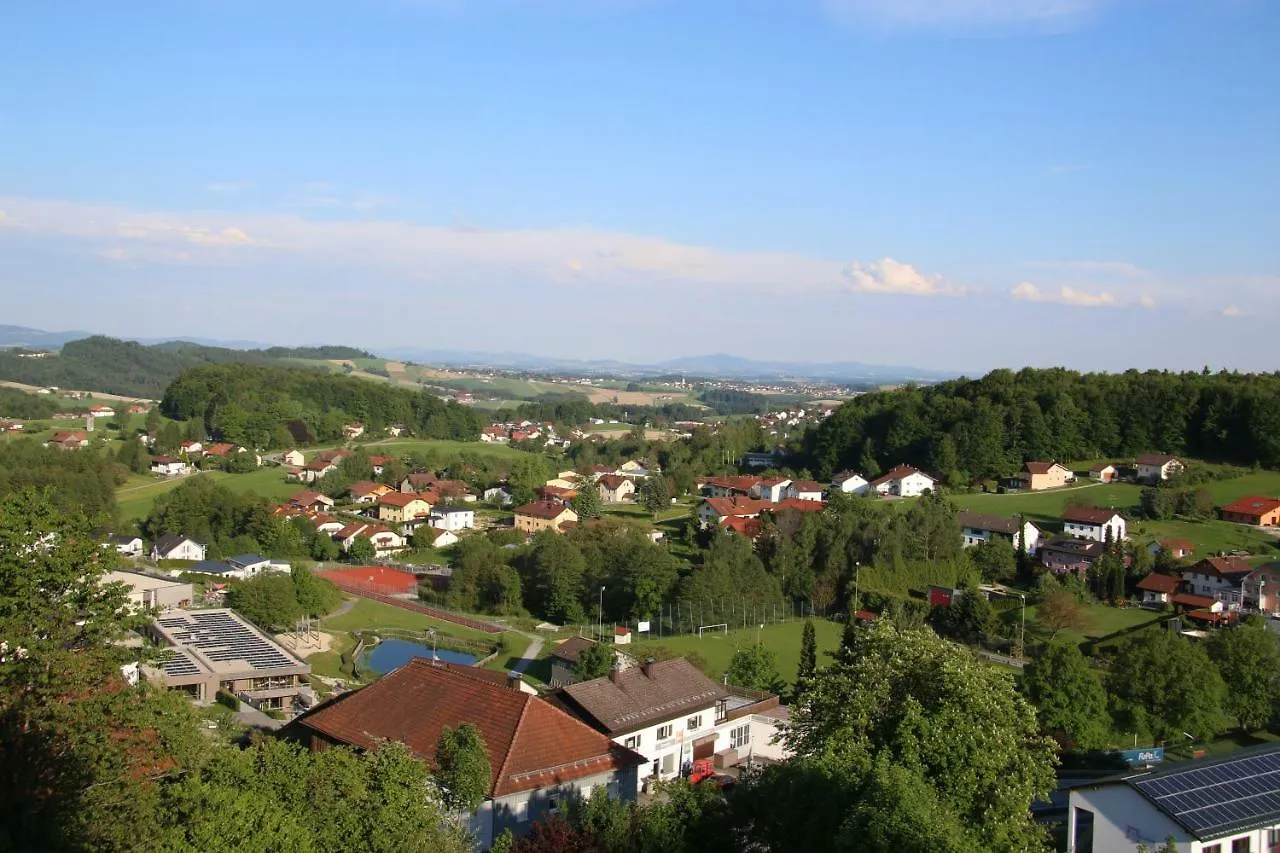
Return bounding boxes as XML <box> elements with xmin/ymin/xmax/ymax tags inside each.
<box><xmin>291</xmin><ymin>658</ymin><xmax>644</xmax><ymax>850</ymax></box>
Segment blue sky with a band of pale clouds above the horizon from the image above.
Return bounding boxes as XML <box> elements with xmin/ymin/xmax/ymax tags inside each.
<box><xmin>0</xmin><ymin>0</ymin><xmax>1280</xmax><ymax>371</ymax></box>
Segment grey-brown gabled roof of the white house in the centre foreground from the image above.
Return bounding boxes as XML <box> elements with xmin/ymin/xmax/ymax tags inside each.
<box><xmin>559</xmin><ymin>657</ymin><xmax>728</xmax><ymax>734</ymax></box>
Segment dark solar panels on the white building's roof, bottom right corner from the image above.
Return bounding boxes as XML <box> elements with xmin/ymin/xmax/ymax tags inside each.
<box><xmin>1133</xmin><ymin>752</ymin><xmax>1280</xmax><ymax>835</ymax></box>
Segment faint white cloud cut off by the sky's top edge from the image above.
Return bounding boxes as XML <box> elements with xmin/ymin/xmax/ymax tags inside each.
<box><xmin>823</xmin><ymin>0</ymin><xmax>1103</xmax><ymax>28</ymax></box>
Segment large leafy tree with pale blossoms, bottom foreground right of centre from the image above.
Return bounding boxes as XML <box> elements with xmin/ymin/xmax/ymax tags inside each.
<box><xmin>748</xmin><ymin>620</ymin><xmax>1055</xmax><ymax>853</ymax></box>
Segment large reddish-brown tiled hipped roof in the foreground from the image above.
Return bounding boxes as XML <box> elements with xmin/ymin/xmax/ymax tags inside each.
<box><xmin>296</xmin><ymin>658</ymin><xmax>645</xmax><ymax>798</ymax></box>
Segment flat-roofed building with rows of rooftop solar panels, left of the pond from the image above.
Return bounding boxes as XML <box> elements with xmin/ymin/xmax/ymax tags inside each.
<box><xmin>143</xmin><ymin>608</ymin><xmax>314</xmax><ymax>711</ymax></box>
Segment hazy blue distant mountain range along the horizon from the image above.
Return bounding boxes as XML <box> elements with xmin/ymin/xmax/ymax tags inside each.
<box><xmin>0</xmin><ymin>325</ymin><xmax>959</xmax><ymax>383</ymax></box>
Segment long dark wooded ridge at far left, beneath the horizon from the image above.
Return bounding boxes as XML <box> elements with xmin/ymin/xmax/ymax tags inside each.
<box><xmin>0</xmin><ymin>336</ymin><xmax>372</xmax><ymax>400</ymax></box>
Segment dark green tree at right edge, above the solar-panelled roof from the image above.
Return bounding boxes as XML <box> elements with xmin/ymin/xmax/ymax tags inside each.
<box><xmin>1208</xmin><ymin>624</ymin><xmax>1280</xmax><ymax>730</ymax></box>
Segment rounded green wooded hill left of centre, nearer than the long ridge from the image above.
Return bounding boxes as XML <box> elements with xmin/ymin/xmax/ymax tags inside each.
<box><xmin>160</xmin><ymin>364</ymin><xmax>484</xmax><ymax>448</ymax></box>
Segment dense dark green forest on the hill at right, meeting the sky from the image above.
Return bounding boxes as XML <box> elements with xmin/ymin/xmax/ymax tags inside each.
<box><xmin>808</xmin><ymin>369</ymin><xmax>1280</xmax><ymax>482</ymax></box>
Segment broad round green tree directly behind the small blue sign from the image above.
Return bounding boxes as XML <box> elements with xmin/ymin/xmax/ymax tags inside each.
<box><xmin>1106</xmin><ymin>629</ymin><xmax>1225</xmax><ymax>740</ymax></box>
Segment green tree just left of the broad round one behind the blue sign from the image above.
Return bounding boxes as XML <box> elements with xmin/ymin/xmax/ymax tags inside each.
<box><xmin>1021</xmin><ymin>639</ymin><xmax>1110</xmax><ymax>749</ymax></box>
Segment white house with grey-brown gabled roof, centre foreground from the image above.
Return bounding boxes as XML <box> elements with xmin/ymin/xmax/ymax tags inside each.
<box><xmin>553</xmin><ymin>657</ymin><xmax>781</xmax><ymax>783</ymax></box>
